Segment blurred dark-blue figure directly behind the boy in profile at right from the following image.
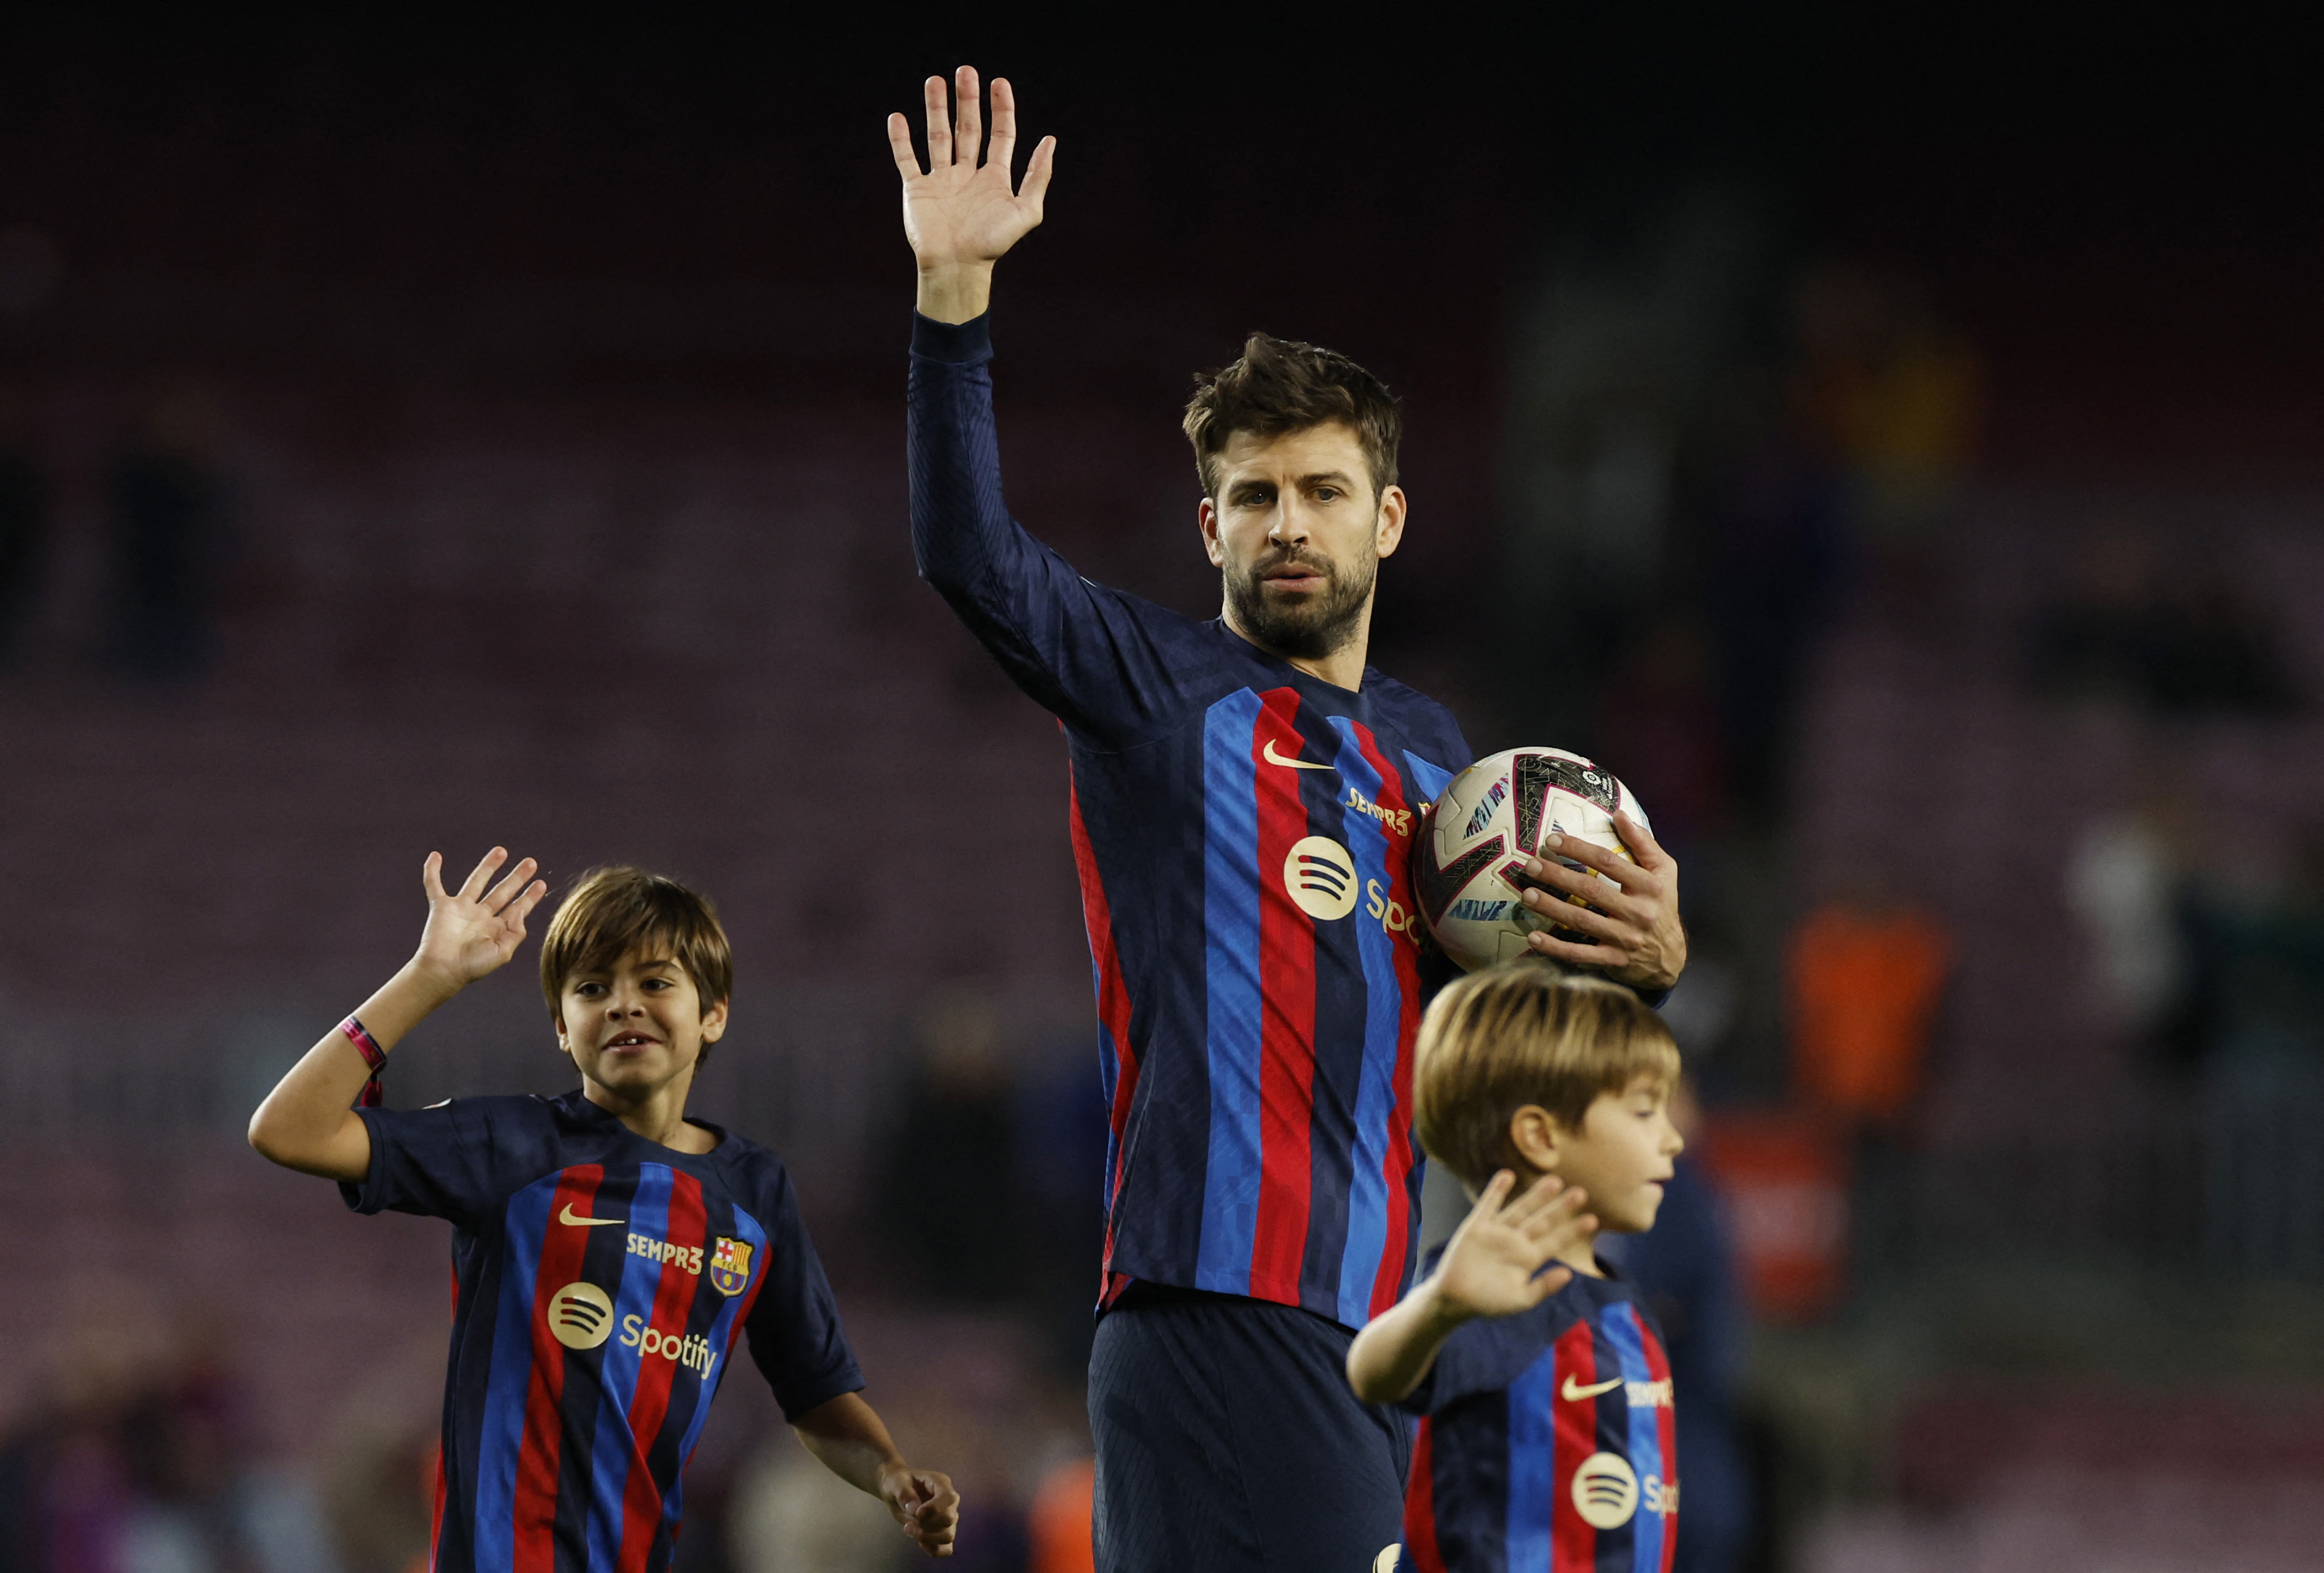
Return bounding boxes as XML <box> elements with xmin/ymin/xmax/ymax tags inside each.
<box><xmin>1608</xmin><ymin>1078</ymin><xmax>1753</xmax><ymax>1573</ymax></box>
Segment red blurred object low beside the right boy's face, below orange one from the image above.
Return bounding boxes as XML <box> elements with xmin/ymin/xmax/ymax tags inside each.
<box><xmin>1701</xmin><ymin>1113</ymin><xmax>1848</xmax><ymax>1322</ymax></box>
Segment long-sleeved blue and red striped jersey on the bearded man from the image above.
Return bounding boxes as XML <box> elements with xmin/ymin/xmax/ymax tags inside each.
<box><xmin>911</xmin><ymin>319</ymin><xmax>1469</xmax><ymax>1327</ymax></box>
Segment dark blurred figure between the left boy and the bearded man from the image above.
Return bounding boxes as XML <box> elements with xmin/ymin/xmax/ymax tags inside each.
<box><xmin>878</xmin><ymin>990</ymin><xmax>1025</xmax><ymax>1306</ymax></box>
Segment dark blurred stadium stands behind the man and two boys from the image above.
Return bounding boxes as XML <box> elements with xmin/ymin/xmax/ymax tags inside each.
<box><xmin>0</xmin><ymin>12</ymin><xmax>2324</xmax><ymax>1573</ymax></box>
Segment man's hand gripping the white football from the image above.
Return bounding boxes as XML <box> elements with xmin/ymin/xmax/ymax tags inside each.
<box><xmin>1525</xmin><ymin>813</ymin><xmax>1687</xmax><ymax>1003</ymax></box>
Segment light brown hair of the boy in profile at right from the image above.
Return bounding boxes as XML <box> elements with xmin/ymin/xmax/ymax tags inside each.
<box><xmin>1413</xmin><ymin>962</ymin><xmax>1678</xmax><ymax>1189</ymax></box>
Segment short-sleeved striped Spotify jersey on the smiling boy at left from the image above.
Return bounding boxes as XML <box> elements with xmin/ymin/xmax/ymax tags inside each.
<box><xmin>339</xmin><ymin>1092</ymin><xmax>862</xmax><ymax>1573</ymax></box>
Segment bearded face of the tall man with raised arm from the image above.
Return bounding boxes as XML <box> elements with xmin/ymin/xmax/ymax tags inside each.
<box><xmin>1201</xmin><ymin>420</ymin><xmax>1404</xmax><ymax>660</ymax></box>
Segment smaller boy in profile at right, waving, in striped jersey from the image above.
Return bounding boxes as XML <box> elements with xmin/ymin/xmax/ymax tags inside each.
<box><xmin>1348</xmin><ymin>962</ymin><xmax>1685</xmax><ymax>1573</ymax></box>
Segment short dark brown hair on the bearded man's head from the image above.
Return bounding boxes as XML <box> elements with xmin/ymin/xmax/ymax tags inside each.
<box><xmin>1185</xmin><ymin>332</ymin><xmax>1404</xmax><ymax>500</ymax></box>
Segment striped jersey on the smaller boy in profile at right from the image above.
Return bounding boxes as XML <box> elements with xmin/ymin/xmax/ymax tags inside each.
<box><xmin>1401</xmin><ymin>1262</ymin><xmax>1678</xmax><ymax>1573</ymax></box>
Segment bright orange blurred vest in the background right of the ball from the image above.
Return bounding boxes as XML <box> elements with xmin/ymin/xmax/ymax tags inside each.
<box><xmin>1789</xmin><ymin>906</ymin><xmax>1952</xmax><ymax>1124</ymax></box>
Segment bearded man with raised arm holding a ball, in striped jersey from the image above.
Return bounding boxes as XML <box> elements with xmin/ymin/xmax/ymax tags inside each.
<box><xmin>888</xmin><ymin>68</ymin><xmax>1685</xmax><ymax>1573</ymax></box>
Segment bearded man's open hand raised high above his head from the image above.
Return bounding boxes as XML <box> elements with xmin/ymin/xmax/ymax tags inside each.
<box><xmin>888</xmin><ymin>65</ymin><xmax>1058</xmax><ymax>323</ymax></box>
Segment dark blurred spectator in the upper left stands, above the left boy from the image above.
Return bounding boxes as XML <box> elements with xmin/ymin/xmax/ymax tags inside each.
<box><xmin>109</xmin><ymin>385</ymin><xmax>225</xmax><ymax>678</ymax></box>
